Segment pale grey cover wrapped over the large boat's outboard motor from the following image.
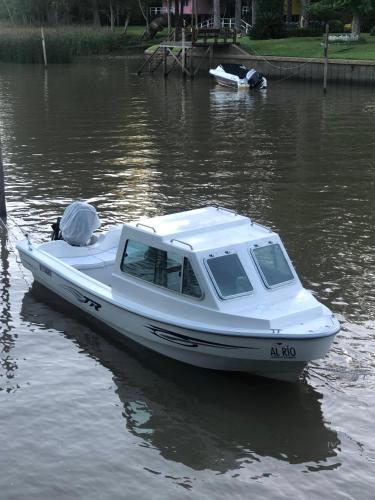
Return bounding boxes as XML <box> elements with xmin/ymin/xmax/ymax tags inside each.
<box><xmin>60</xmin><ymin>201</ymin><xmax>101</xmax><ymax>247</ymax></box>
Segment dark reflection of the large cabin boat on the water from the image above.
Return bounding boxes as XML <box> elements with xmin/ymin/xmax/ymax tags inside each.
<box><xmin>21</xmin><ymin>284</ymin><xmax>340</xmax><ymax>473</ymax></box>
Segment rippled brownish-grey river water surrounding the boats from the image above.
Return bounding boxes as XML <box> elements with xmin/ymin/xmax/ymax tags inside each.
<box><xmin>0</xmin><ymin>58</ymin><xmax>375</xmax><ymax>500</ymax></box>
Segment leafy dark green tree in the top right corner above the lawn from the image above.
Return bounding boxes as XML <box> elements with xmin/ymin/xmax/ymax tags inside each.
<box><xmin>309</xmin><ymin>0</ymin><xmax>375</xmax><ymax>36</ymax></box>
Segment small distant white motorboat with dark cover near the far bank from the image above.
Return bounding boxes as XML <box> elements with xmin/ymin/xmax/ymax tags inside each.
<box><xmin>209</xmin><ymin>64</ymin><xmax>268</xmax><ymax>89</ymax></box>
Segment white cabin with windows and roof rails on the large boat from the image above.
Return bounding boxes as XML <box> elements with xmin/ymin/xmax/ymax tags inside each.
<box><xmin>112</xmin><ymin>207</ymin><xmax>298</xmax><ymax>307</ymax></box>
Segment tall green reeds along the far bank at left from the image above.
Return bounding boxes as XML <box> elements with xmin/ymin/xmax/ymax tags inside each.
<box><xmin>0</xmin><ymin>26</ymin><xmax>163</xmax><ymax>64</ymax></box>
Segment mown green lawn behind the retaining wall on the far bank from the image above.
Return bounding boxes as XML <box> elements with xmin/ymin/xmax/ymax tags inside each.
<box><xmin>241</xmin><ymin>35</ymin><xmax>375</xmax><ymax>60</ymax></box>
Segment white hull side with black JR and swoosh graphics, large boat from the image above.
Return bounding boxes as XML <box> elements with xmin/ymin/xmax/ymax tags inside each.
<box><xmin>18</xmin><ymin>247</ymin><xmax>336</xmax><ymax>382</ymax></box>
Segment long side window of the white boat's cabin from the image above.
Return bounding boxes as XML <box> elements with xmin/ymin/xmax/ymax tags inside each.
<box><xmin>121</xmin><ymin>240</ymin><xmax>202</xmax><ymax>298</ymax></box>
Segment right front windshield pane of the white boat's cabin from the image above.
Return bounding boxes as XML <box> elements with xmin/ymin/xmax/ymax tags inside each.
<box><xmin>252</xmin><ymin>243</ymin><xmax>294</xmax><ymax>288</ymax></box>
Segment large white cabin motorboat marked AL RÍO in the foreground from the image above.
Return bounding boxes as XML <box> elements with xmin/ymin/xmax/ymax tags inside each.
<box><xmin>17</xmin><ymin>204</ymin><xmax>339</xmax><ymax>381</ymax></box>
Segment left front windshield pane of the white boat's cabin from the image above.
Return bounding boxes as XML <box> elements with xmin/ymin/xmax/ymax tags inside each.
<box><xmin>206</xmin><ymin>254</ymin><xmax>253</xmax><ymax>299</ymax></box>
